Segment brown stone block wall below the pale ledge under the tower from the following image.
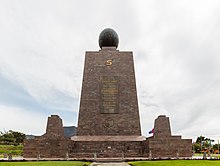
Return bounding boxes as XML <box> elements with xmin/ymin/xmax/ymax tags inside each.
<box><xmin>69</xmin><ymin>141</ymin><xmax>143</xmax><ymax>158</ymax></box>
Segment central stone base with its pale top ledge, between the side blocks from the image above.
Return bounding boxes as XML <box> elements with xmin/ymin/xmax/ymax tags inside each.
<box><xmin>70</xmin><ymin>136</ymin><xmax>146</xmax><ymax>158</ymax></box>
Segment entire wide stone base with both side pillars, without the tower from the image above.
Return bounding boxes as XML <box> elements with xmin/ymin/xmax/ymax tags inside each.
<box><xmin>24</xmin><ymin>115</ymin><xmax>192</xmax><ymax>160</ymax></box>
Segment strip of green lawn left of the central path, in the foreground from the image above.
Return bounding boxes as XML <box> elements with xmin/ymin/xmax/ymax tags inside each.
<box><xmin>0</xmin><ymin>161</ymin><xmax>90</xmax><ymax>166</ymax></box>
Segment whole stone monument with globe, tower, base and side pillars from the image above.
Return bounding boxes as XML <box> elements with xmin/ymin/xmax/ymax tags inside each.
<box><xmin>24</xmin><ymin>28</ymin><xmax>192</xmax><ymax>159</ymax></box>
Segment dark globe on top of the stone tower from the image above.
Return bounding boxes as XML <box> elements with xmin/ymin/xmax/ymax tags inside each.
<box><xmin>99</xmin><ymin>28</ymin><xmax>119</xmax><ymax>49</ymax></box>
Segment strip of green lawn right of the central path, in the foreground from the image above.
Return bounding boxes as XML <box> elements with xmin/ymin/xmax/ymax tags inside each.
<box><xmin>129</xmin><ymin>160</ymin><xmax>220</xmax><ymax>166</ymax></box>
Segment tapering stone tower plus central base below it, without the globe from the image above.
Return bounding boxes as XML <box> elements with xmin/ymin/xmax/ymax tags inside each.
<box><xmin>70</xmin><ymin>47</ymin><xmax>145</xmax><ymax>158</ymax></box>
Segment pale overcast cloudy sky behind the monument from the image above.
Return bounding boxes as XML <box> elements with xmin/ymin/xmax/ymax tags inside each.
<box><xmin>0</xmin><ymin>0</ymin><xmax>220</xmax><ymax>140</ymax></box>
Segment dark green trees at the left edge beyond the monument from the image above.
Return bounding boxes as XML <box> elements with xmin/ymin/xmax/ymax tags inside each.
<box><xmin>0</xmin><ymin>130</ymin><xmax>26</xmax><ymax>145</ymax></box>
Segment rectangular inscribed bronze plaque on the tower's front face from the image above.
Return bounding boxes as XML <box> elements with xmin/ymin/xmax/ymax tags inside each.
<box><xmin>100</xmin><ymin>76</ymin><xmax>118</xmax><ymax>114</ymax></box>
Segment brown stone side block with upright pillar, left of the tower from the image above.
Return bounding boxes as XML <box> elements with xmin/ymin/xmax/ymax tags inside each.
<box><xmin>23</xmin><ymin>115</ymin><xmax>70</xmax><ymax>158</ymax></box>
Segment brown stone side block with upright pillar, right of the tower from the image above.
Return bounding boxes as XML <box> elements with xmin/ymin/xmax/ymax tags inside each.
<box><xmin>145</xmin><ymin>115</ymin><xmax>192</xmax><ymax>158</ymax></box>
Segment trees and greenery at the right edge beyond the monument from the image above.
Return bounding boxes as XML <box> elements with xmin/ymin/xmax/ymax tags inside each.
<box><xmin>192</xmin><ymin>136</ymin><xmax>219</xmax><ymax>153</ymax></box>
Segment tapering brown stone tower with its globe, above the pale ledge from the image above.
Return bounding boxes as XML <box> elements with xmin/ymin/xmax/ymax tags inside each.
<box><xmin>77</xmin><ymin>28</ymin><xmax>141</xmax><ymax>136</ymax></box>
